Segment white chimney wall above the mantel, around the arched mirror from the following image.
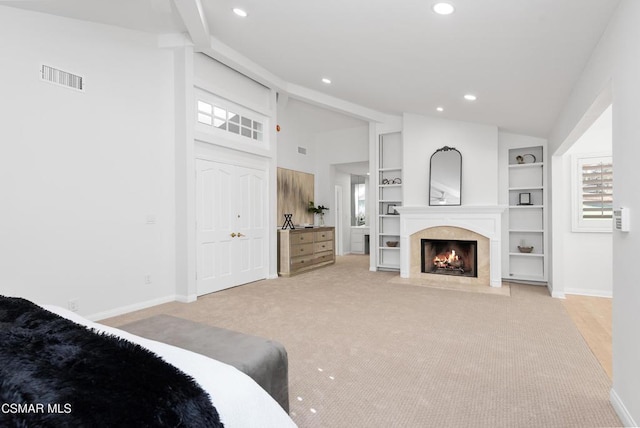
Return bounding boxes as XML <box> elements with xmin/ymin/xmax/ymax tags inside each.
<box><xmin>402</xmin><ymin>114</ymin><xmax>498</xmax><ymax>206</ymax></box>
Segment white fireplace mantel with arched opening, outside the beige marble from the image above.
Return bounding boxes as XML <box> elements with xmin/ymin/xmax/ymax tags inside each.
<box><xmin>396</xmin><ymin>205</ymin><xmax>506</xmax><ymax>287</ymax></box>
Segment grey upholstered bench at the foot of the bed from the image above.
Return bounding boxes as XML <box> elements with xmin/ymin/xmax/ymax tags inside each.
<box><xmin>118</xmin><ymin>315</ymin><xmax>289</xmax><ymax>413</ymax></box>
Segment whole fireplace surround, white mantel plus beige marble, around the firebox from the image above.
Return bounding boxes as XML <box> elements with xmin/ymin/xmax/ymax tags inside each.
<box><xmin>397</xmin><ymin>205</ymin><xmax>505</xmax><ymax>287</ymax></box>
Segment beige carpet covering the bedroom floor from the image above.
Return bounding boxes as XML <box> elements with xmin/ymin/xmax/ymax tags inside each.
<box><xmin>104</xmin><ymin>256</ymin><xmax>620</xmax><ymax>428</ymax></box>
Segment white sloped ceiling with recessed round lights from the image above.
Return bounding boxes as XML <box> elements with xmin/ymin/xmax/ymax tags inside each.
<box><xmin>0</xmin><ymin>0</ymin><xmax>619</xmax><ymax>137</ymax></box>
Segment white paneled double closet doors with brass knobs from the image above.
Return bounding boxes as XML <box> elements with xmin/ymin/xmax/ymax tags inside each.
<box><xmin>196</xmin><ymin>159</ymin><xmax>267</xmax><ymax>295</ymax></box>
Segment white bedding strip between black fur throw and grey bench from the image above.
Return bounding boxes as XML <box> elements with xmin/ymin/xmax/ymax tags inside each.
<box><xmin>43</xmin><ymin>306</ymin><xmax>296</xmax><ymax>428</ymax></box>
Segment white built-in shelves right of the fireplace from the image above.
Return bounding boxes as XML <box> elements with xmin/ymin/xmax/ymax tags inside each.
<box><xmin>507</xmin><ymin>146</ymin><xmax>548</xmax><ymax>282</ymax></box>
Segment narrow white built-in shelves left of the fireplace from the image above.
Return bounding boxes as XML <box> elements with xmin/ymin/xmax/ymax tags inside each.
<box><xmin>376</xmin><ymin>132</ymin><xmax>402</xmax><ymax>270</ymax></box>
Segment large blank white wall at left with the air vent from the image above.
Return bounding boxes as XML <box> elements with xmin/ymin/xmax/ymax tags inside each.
<box><xmin>0</xmin><ymin>7</ymin><xmax>175</xmax><ymax>320</ymax></box>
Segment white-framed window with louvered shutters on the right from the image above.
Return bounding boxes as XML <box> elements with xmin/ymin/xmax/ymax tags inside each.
<box><xmin>574</xmin><ymin>156</ymin><xmax>613</xmax><ymax>232</ymax></box>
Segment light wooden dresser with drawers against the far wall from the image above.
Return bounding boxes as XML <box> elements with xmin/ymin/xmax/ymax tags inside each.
<box><xmin>278</xmin><ymin>227</ymin><xmax>336</xmax><ymax>276</ymax></box>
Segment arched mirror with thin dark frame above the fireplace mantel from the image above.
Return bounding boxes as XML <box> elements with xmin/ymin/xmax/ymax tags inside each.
<box><xmin>429</xmin><ymin>146</ymin><xmax>462</xmax><ymax>205</ymax></box>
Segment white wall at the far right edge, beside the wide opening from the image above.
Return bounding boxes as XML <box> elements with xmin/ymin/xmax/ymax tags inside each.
<box><xmin>550</xmin><ymin>0</ymin><xmax>640</xmax><ymax>426</ymax></box>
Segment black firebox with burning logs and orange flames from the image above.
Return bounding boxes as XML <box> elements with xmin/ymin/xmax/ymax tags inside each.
<box><xmin>420</xmin><ymin>239</ymin><xmax>478</xmax><ymax>278</ymax></box>
